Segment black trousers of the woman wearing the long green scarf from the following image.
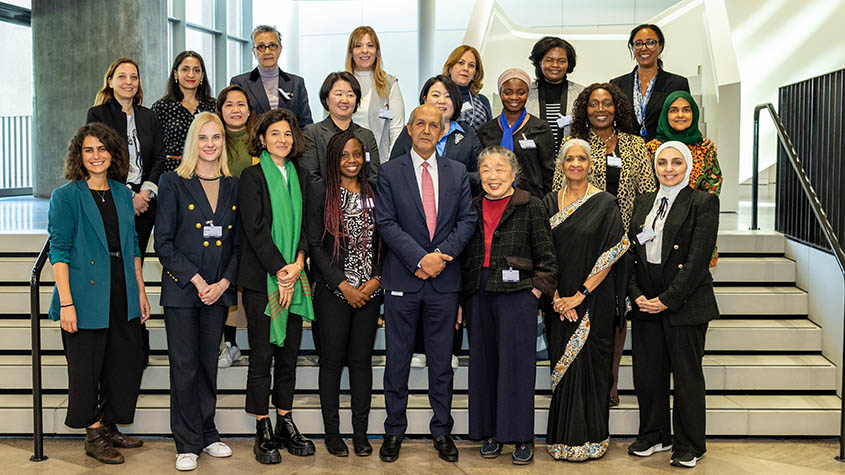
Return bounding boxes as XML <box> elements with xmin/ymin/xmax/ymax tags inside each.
<box><xmin>243</xmin><ymin>289</ymin><xmax>302</xmax><ymax>416</ymax></box>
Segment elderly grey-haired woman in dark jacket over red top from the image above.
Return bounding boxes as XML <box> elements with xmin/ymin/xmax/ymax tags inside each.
<box><xmin>461</xmin><ymin>146</ymin><xmax>557</xmax><ymax>465</ymax></box>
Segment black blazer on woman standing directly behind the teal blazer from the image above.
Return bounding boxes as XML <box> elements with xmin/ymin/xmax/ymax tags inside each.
<box><xmin>85</xmin><ymin>99</ymin><xmax>164</xmax><ymax>192</ymax></box>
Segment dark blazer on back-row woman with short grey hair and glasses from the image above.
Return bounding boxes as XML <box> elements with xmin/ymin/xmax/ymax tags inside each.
<box><xmin>231</xmin><ymin>68</ymin><xmax>314</xmax><ymax>127</ymax></box>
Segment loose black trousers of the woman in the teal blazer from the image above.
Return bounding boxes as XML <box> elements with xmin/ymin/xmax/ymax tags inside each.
<box><xmin>62</xmin><ymin>314</ymin><xmax>144</xmax><ymax>429</ymax></box>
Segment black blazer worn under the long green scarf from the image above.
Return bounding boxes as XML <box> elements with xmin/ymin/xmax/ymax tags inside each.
<box><xmin>238</xmin><ymin>163</ymin><xmax>309</xmax><ymax>292</ymax></box>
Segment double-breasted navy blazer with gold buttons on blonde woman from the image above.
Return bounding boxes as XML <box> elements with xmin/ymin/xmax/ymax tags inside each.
<box><xmin>155</xmin><ymin>172</ymin><xmax>241</xmax><ymax>307</ymax></box>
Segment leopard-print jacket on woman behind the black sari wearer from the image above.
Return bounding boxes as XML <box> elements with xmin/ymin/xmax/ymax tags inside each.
<box><xmin>552</xmin><ymin>132</ymin><xmax>657</xmax><ymax>231</ymax></box>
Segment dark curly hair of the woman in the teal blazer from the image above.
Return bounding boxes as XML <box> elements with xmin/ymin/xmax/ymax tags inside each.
<box><xmin>64</xmin><ymin>122</ymin><xmax>129</xmax><ymax>183</ymax></box>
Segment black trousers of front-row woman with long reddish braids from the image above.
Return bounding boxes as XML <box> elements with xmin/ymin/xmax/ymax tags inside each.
<box><xmin>314</xmin><ymin>284</ymin><xmax>382</xmax><ymax>435</ymax></box>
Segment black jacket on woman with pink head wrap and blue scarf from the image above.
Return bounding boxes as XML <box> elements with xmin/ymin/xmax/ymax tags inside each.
<box><xmin>478</xmin><ymin>115</ymin><xmax>555</xmax><ymax>200</ymax></box>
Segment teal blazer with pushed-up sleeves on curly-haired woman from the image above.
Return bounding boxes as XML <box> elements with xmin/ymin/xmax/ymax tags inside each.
<box><xmin>47</xmin><ymin>179</ymin><xmax>141</xmax><ymax>330</ymax></box>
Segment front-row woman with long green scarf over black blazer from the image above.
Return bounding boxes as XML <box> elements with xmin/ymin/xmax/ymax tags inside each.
<box><xmin>238</xmin><ymin>109</ymin><xmax>314</xmax><ymax>464</ymax></box>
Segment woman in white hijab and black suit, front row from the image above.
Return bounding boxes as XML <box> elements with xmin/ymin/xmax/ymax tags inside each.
<box><xmin>628</xmin><ymin>141</ymin><xmax>719</xmax><ymax>467</ymax></box>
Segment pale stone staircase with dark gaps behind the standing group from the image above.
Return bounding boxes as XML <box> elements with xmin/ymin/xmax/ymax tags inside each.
<box><xmin>0</xmin><ymin>231</ymin><xmax>840</xmax><ymax>436</ymax></box>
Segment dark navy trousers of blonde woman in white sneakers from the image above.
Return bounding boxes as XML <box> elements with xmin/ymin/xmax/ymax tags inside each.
<box><xmin>164</xmin><ymin>305</ymin><xmax>224</xmax><ymax>455</ymax></box>
